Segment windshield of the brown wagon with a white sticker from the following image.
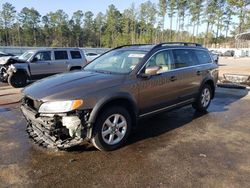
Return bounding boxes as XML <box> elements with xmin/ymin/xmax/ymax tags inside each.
<box><xmin>84</xmin><ymin>49</ymin><xmax>147</xmax><ymax>74</ymax></box>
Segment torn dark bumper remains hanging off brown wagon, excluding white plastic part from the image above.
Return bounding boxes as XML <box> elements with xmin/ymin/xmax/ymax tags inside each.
<box><xmin>21</xmin><ymin>105</ymin><xmax>83</xmax><ymax>149</ymax></box>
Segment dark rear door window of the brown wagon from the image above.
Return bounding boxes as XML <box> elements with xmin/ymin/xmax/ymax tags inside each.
<box><xmin>173</xmin><ymin>49</ymin><xmax>197</xmax><ymax>69</ymax></box>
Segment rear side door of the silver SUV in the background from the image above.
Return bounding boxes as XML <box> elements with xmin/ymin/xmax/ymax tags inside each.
<box><xmin>52</xmin><ymin>50</ymin><xmax>69</xmax><ymax>73</ymax></box>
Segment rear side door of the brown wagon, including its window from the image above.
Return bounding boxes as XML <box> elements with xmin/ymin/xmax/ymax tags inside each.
<box><xmin>172</xmin><ymin>48</ymin><xmax>201</xmax><ymax>101</ymax></box>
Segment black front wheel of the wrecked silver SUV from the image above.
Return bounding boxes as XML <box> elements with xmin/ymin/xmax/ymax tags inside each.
<box><xmin>8</xmin><ymin>72</ymin><xmax>27</xmax><ymax>88</ymax></box>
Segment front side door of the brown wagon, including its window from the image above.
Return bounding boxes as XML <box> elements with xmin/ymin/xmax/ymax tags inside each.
<box><xmin>138</xmin><ymin>50</ymin><xmax>184</xmax><ymax>116</ymax></box>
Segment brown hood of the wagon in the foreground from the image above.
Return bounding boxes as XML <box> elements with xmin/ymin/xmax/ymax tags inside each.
<box><xmin>22</xmin><ymin>71</ymin><xmax>124</xmax><ymax>102</ymax></box>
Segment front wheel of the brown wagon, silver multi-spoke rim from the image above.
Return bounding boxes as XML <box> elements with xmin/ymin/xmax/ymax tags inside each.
<box><xmin>91</xmin><ymin>107</ymin><xmax>132</xmax><ymax>151</ymax></box>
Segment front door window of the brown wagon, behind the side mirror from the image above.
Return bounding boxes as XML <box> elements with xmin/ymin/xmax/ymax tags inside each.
<box><xmin>146</xmin><ymin>50</ymin><xmax>174</xmax><ymax>74</ymax></box>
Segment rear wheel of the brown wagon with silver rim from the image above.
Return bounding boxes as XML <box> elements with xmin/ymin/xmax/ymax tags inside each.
<box><xmin>193</xmin><ymin>84</ymin><xmax>212</xmax><ymax>112</ymax></box>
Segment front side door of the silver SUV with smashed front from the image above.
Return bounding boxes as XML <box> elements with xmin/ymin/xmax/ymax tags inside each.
<box><xmin>29</xmin><ymin>51</ymin><xmax>52</xmax><ymax>79</ymax></box>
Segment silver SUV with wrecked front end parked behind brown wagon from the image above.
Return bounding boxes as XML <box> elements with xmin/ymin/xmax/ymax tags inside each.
<box><xmin>0</xmin><ymin>48</ymin><xmax>87</xmax><ymax>87</ymax></box>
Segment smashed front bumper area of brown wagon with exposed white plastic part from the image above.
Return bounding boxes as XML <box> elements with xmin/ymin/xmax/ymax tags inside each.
<box><xmin>21</xmin><ymin>105</ymin><xmax>89</xmax><ymax>149</ymax></box>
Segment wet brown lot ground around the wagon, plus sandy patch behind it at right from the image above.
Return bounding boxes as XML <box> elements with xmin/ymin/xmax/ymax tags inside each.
<box><xmin>0</xmin><ymin>58</ymin><xmax>250</xmax><ymax>187</ymax></box>
